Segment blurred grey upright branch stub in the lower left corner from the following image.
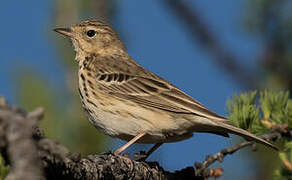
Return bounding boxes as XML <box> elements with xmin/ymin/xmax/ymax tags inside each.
<box><xmin>0</xmin><ymin>96</ymin><xmax>43</xmax><ymax>180</ymax></box>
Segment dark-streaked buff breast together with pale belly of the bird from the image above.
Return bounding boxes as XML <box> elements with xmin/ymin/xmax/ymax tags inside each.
<box><xmin>79</xmin><ymin>70</ymin><xmax>192</xmax><ymax>143</ymax></box>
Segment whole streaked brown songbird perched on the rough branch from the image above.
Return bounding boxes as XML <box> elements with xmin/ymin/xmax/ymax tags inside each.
<box><xmin>54</xmin><ymin>19</ymin><xmax>278</xmax><ymax>159</ymax></box>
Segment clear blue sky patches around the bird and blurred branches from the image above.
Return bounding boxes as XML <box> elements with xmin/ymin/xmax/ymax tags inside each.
<box><xmin>0</xmin><ymin>0</ymin><xmax>261</xmax><ymax>179</ymax></box>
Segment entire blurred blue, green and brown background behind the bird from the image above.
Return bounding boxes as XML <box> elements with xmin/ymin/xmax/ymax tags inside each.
<box><xmin>0</xmin><ymin>0</ymin><xmax>292</xmax><ymax>179</ymax></box>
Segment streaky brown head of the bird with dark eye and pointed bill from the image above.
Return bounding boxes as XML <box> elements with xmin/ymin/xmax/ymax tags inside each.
<box><xmin>54</xmin><ymin>20</ymin><xmax>125</xmax><ymax>58</ymax></box>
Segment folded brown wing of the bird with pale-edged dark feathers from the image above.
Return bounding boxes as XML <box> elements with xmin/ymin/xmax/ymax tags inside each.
<box><xmin>97</xmin><ymin>73</ymin><xmax>226</xmax><ymax>121</ymax></box>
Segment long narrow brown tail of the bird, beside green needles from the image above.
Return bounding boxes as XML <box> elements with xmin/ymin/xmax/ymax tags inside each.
<box><xmin>216</xmin><ymin>121</ymin><xmax>279</xmax><ymax>151</ymax></box>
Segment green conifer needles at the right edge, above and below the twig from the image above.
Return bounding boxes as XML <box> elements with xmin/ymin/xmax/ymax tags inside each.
<box><xmin>227</xmin><ymin>90</ymin><xmax>292</xmax><ymax>180</ymax></box>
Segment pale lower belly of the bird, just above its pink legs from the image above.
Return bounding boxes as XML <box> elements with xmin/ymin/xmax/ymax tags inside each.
<box><xmin>82</xmin><ymin>98</ymin><xmax>192</xmax><ymax>144</ymax></box>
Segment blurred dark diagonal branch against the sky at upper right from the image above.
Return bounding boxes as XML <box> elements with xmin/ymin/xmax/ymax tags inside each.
<box><xmin>163</xmin><ymin>0</ymin><xmax>258</xmax><ymax>89</ymax></box>
